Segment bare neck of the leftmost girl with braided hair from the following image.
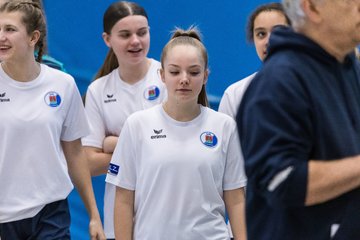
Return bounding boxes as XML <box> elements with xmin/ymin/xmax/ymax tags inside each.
<box><xmin>1</xmin><ymin>59</ymin><xmax>40</xmax><ymax>82</ymax></box>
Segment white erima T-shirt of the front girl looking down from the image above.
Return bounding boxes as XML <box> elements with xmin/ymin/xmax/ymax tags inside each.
<box><xmin>106</xmin><ymin>105</ymin><xmax>246</xmax><ymax>240</ymax></box>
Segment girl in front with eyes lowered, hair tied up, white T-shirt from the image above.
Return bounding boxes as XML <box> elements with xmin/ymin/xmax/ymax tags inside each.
<box><xmin>106</xmin><ymin>28</ymin><xmax>246</xmax><ymax>240</ymax></box>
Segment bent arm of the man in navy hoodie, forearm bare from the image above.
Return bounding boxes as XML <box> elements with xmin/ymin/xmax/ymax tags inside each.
<box><xmin>238</xmin><ymin>68</ymin><xmax>360</xmax><ymax>206</ymax></box>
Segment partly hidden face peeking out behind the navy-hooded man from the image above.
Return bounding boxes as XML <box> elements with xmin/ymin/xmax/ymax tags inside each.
<box><xmin>253</xmin><ymin>10</ymin><xmax>288</xmax><ymax>61</ymax></box>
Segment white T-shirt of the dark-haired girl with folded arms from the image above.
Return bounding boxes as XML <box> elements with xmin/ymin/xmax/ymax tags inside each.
<box><xmin>82</xmin><ymin>59</ymin><xmax>167</xmax><ymax>238</ymax></box>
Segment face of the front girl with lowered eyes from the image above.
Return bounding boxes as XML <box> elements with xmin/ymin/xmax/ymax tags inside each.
<box><xmin>161</xmin><ymin>45</ymin><xmax>208</xmax><ymax>104</ymax></box>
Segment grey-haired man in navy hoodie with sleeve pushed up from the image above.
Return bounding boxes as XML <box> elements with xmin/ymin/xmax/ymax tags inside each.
<box><xmin>236</xmin><ymin>0</ymin><xmax>360</xmax><ymax>240</ymax></box>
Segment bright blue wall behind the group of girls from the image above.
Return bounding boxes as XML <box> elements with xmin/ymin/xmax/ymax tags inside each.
<box><xmin>44</xmin><ymin>0</ymin><xmax>276</xmax><ymax>240</ymax></box>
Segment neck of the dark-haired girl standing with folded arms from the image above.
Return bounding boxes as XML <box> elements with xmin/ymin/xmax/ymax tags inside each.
<box><xmin>119</xmin><ymin>58</ymin><xmax>151</xmax><ymax>84</ymax></box>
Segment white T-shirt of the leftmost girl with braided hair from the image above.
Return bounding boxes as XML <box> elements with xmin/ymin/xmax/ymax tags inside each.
<box><xmin>0</xmin><ymin>64</ymin><xmax>89</xmax><ymax>223</ymax></box>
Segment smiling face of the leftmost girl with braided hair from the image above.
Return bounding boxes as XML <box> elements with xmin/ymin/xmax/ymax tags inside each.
<box><xmin>0</xmin><ymin>11</ymin><xmax>36</xmax><ymax>62</ymax></box>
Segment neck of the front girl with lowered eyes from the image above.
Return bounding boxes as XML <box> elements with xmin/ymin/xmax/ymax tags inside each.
<box><xmin>163</xmin><ymin>101</ymin><xmax>201</xmax><ymax>122</ymax></box>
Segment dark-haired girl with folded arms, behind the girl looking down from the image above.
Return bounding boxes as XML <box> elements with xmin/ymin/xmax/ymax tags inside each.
<box><xmin>82</xmin><ymin>1</ymin><xmax>166</xmax><ymax>239</ymax></box>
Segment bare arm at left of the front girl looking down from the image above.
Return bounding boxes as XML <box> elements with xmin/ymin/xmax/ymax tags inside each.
<box><xmin>114</xmin><ymin>187</ymin><xmax>135</xmax><ymax>240</ymax></box>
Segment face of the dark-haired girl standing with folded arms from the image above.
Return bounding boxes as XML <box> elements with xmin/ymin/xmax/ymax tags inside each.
<box><xmin>103</xmin><ymin>15</ymin><xmax>150</xmax><ymax>65</ymax></box>
